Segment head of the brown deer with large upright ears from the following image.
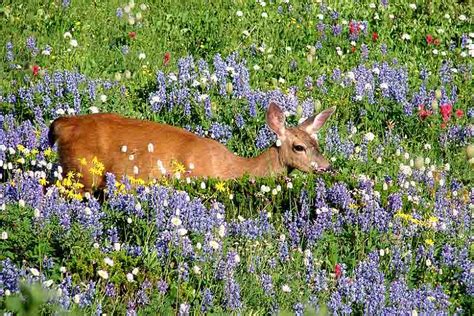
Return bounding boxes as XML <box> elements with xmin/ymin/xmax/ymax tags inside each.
<box><xmin>267</xmin><ymin>101</ymin><xmax>336</xmax><ymax>172</ymax></box>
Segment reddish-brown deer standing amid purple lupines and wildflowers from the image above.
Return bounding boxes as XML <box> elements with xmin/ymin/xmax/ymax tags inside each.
<box><xmin>48</xmin><ymin>101</ymin><xmax>336</xmax><ymax>192</ymax></box>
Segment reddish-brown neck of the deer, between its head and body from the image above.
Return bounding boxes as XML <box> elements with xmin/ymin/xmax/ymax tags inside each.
<box><xmin>242</xmin><ymin>146</ymin><xmax>287</xmax><ymax>177</ymax></box>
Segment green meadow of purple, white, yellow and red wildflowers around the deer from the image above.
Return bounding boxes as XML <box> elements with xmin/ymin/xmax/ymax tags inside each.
<box><xmin>0</xmin><ymin>0</ymin><xmax>474</xmax><ymax>316</ymax></box>
